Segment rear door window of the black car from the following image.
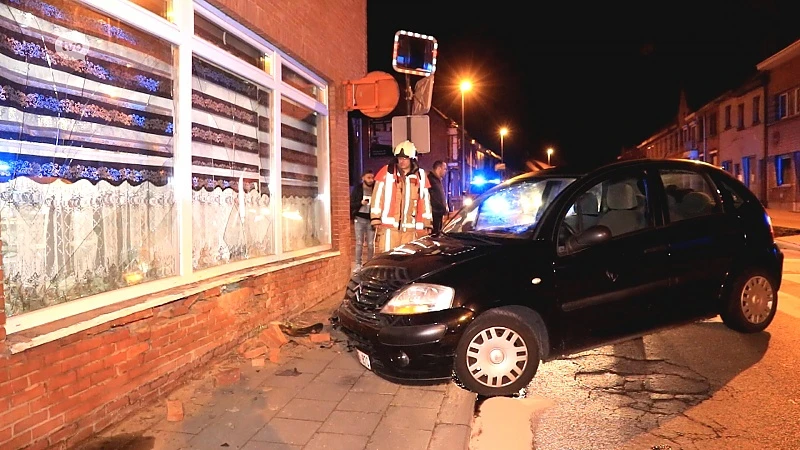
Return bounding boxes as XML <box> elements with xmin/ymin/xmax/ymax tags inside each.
<box><xmin>661</xmin><ymin>170</ymin><xmax>720</xmax><ymax>222</ymax></box>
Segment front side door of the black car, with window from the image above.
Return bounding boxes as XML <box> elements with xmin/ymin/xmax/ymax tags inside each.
<box><xmin>554</xmin><ymin>170</ymin><xmax>669</xmax><ymax>351</ymax></box>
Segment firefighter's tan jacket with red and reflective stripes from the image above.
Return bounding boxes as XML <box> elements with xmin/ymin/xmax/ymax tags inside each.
<box><xmin>370</xmin><ymin>164</ymin><xmax>433</xmax><ymax>231</ymax></box>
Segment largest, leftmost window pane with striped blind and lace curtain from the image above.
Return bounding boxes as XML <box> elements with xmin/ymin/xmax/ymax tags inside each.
<box><xmin>0</xmin><ymin>1</ymin><xmax>178</xmax><ymax>316</ymax></box>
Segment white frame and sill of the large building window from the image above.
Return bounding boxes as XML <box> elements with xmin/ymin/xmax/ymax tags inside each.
<box><xmin>5</xmin><ymin>0</ymin><xmax>338</xmax><ymax>335</ymax></box>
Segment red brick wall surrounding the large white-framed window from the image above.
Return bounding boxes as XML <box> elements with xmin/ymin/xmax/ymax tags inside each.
<box><xmin>0</xmin><ymin>0</ymin><xmax>366</xmax><ymax>449</ymax></box>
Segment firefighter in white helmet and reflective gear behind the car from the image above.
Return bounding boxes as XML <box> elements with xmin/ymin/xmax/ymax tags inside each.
<box><xmin>370</xmin><ymin>141</ymin><xmax>433</xmax><ymax>253</ymax></box>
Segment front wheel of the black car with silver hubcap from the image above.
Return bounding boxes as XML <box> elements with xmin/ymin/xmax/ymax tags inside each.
<box><xmin>453</xmin><ymin>307</ymin><xmax>541</xmax><ymax>397</ymax></box>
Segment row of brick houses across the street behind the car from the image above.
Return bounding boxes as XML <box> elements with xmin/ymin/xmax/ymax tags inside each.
<box><xmin>619</xmin><ymin>40</ymin><xmax>800</xmax><ymax>211</ymax></box>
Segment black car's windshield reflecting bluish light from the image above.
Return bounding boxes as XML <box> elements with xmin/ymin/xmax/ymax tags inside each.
<box><xmin>442</xmin><ymin>178</ymin><xmax>575</xmax><ymax>238</ymax></box>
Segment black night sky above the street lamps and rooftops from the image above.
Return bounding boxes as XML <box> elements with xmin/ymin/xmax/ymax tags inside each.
<box><xmin>367</xmin><ymin>0</ymin><xmax>800</xmax><ymax>168</ymax></box>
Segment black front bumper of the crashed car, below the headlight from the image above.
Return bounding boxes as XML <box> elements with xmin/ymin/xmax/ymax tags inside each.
<box><xmin>334</xmin><ymin>300</ymin><xmax>473</xmax><ymax>381</ymax></box>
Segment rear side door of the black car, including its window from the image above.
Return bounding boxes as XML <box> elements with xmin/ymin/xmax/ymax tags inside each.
<box><xmin>658</xmin><ymin>166</ymin><xmax>744</xmax><ymax>320</ymax></box>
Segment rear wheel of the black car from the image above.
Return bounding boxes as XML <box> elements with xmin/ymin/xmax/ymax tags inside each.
<box><xmin>720</xmin><ymin>269</ymin><xmax>778</xmax><ymax>333</ymax></box>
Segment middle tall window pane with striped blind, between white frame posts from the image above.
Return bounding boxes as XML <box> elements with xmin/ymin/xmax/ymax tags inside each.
<box><xmin>192</xmin><ymin>57</ymin><xmax>274</xmax><ymax>269</ymax></box>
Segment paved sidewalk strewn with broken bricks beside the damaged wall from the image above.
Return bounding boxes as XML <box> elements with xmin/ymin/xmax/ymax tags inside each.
<box><xmin>78</xmin><ymin>298</ymin><xmax>476</xmax><ymax>450</ymax></box>
